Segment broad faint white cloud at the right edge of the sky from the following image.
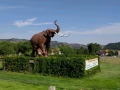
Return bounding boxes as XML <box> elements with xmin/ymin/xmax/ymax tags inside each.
<box><xmin>72</xmin><ymin>23</ymin><xmax>120</xmax><ymax>34</ymax></box>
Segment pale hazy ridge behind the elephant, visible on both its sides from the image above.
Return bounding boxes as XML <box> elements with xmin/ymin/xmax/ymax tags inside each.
<box><xmin>0</xmin><ymin>38</ymin><xmax>87</xmax><ymax>48</ymax></box>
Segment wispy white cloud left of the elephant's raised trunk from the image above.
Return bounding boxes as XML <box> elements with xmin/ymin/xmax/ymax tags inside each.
<box><xmin>13</xmin><ymin>18</ymin><xmax>53</xmax><ymax>27</ymax></box>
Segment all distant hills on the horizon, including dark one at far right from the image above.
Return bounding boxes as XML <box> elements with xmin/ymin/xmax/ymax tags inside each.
<box><xmin>0</xmin><ymin>38</ymin><xmax>120</xmax><ymax>50</ymax></box>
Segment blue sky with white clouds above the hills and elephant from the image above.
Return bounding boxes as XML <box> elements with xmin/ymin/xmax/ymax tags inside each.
<box><xmin>0</xmin><ymin>0</ymin><xmax>120</xmax><ymax>45</ymax></box>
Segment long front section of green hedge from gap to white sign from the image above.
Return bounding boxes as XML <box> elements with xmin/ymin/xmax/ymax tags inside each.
<box><xmin>34</xmin><ymin>57</ymin><xmax>84</xmax><ymax>78</ymax></box>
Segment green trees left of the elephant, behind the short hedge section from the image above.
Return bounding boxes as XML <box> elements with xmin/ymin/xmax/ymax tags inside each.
<box><xmin>0</xmin><ymin>41</ymin><xmax>31</xmax><ymax>55</ymax></box>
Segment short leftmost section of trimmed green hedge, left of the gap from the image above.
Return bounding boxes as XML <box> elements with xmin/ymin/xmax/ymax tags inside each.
<box><xmin>3</xmin><ymin>56</ymin><xmax>29</xmax><ymax>72</ymax></box>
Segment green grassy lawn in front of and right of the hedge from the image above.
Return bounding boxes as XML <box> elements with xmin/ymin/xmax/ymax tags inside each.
<box><xmin>0</xmin><ymin>57</ymin><xmax>120</xmax><ymax>90</ymax></box>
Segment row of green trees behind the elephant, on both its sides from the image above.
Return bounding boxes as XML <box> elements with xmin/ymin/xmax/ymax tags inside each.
<box><xmin>0</xmin><ymin>41</ymin><xmax>101</xmax><ymax>56</ymax></box>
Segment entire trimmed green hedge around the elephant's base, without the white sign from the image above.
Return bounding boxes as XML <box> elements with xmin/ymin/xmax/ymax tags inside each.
<box><xmin>3</xmin><ymin>56</ymin><xmax>100</xmax><ymax>78</ymax></box>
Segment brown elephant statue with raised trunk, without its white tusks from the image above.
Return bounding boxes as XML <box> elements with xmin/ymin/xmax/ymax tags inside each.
<box><xmin>30</xmin><ymin>20</ymin><xmax>60</xmax><ymax>57</ymax></box>
